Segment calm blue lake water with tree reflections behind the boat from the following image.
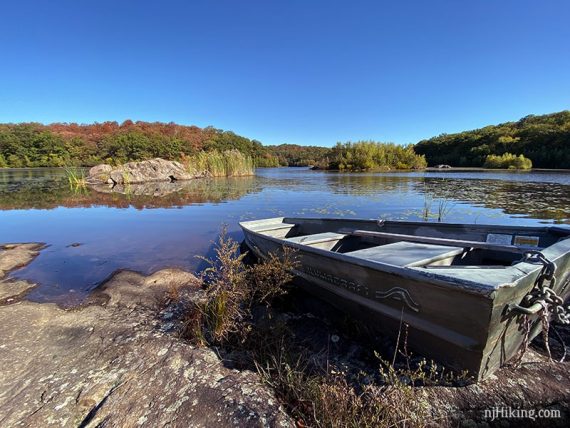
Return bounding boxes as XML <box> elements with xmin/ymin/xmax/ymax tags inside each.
<box><xmin>0</xmin><ymin>168</ymin><xmax>570</xmax><ymax>303</ymax></box>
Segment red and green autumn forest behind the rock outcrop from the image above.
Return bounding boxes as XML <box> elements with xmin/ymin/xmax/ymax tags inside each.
<box><xmin>0</xmin><ymin>120</ymin><xmax>277</xmax><ymax>168</ymax></box>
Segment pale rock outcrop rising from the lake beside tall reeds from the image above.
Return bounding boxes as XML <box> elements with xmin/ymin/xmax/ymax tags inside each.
<box><xmin>87</xmin><ymin>158</ymin><xmax>208</xmax><ymax>185</ymax></box>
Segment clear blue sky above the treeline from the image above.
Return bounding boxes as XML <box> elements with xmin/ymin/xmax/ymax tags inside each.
<box><xmin>0</xmin><ymin>0</ymin><xmax>570</xmax><ymax>145</ymax></box>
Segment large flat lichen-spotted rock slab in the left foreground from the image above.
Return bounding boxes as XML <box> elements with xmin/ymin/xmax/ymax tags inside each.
<box><xmin>0</xmin><ymin>269</ymin><xmax>290</xmax><ymax>427</ymax></box>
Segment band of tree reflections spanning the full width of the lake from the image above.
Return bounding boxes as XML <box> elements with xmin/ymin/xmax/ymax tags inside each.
<box><xmin>0</xmin><ymin>170</ymin><xmax>570</xmax><ymax>223</ymax></box>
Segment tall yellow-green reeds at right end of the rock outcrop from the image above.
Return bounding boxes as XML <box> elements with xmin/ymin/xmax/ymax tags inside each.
<box><xmin>182</xmin><ymin>150</ymin><xmax>254</xmax><ymax>177</ymax></box>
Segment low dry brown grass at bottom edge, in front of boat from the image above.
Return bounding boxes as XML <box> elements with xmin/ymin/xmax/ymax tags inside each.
<box><xmin>256</xmin><ymin>332</ymin><xmax>428</xmax><ymax>427</ymax></box>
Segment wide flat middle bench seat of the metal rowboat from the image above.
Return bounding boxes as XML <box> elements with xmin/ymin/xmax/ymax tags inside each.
<box><xmin>345</xmin><ymin>241</ymin><xmax>464</xmax><ymax>267</ymax></box>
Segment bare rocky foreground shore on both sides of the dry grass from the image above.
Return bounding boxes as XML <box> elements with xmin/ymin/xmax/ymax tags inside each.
<box><xmin>0</xmin><ymin>244</ymin><xmax>570</xmax><ymax>427</ymax></box>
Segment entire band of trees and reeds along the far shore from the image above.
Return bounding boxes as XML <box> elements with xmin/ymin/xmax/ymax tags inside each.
<box><xmin>0</xmin><ymin>111</ymin><xmax>570</xmax><ymax>172</ymax></box>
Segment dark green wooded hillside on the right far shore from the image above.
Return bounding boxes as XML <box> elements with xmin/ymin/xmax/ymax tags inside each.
<box><xmin>414</xmin><ymin>110</ymin><xmax>570</xmax><ymax>169</ymax></box>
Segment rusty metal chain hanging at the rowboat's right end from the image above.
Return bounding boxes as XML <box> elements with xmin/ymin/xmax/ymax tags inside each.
<box><xmin>511</xmin><ymin>250</ymin><xmax>570</xmax><ymax>366</ymax></box>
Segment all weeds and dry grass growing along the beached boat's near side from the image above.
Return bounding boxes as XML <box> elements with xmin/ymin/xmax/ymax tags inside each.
<box><xmin>182</xmin><ymin>232</ymin><xmax>462</xmax><ymax>427</ymax></box>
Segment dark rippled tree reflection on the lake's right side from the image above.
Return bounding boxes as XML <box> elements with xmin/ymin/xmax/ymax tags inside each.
<box><xmin>414</xmin><ymin>178</ymin><xmax>570</xmax><ymax>223</ymax></box>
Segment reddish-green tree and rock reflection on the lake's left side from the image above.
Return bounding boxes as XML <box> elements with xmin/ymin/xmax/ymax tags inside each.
<box><xmin>0</xmin><ymin>177</ymin><xmax>261</xmax><ymax>209</ymax></box>
